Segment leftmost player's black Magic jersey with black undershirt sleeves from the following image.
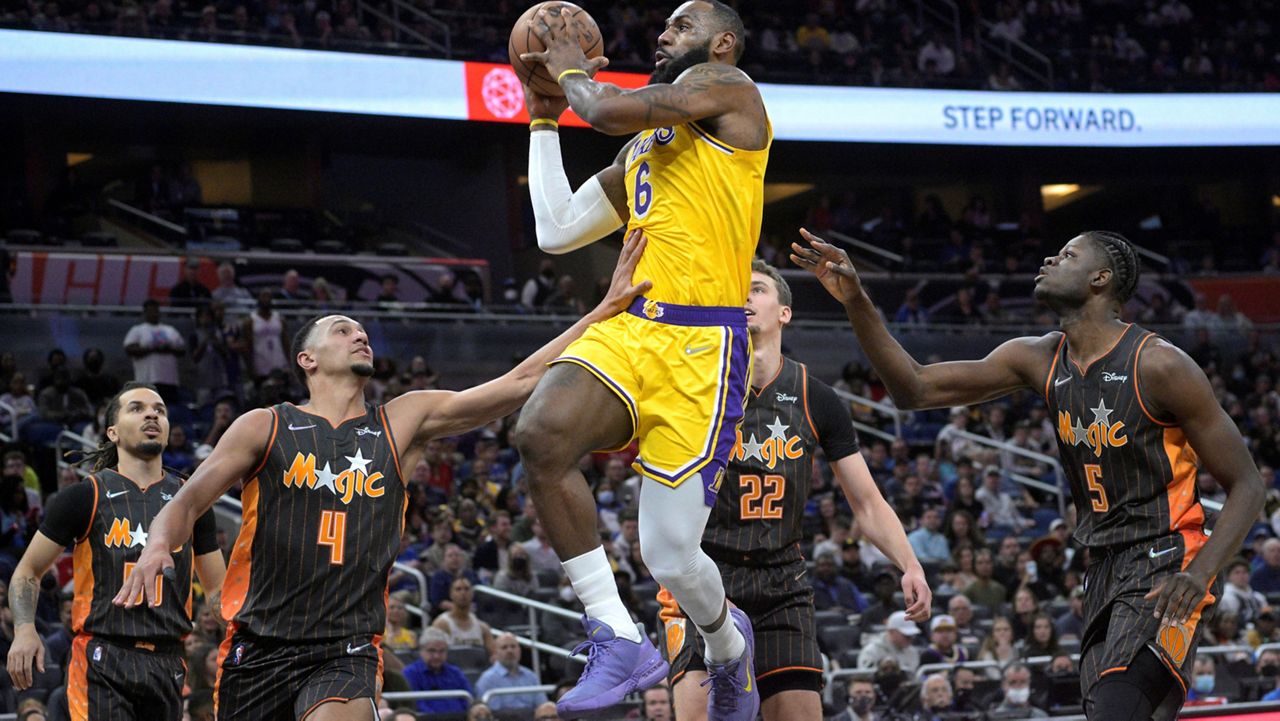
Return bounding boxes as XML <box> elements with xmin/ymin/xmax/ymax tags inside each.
<box><xmin>40</xmin><ymin>470</ymin><xmax>218</xmax><ymax>642</ymax></box>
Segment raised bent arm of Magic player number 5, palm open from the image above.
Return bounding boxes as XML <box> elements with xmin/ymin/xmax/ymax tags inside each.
<box><xmin>791</xmin><ymin>229</ymin><xmax>1056</xmax><ymax>410</ymax></box>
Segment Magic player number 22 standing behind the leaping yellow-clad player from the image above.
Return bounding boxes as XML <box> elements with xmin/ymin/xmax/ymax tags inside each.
<box><xmin>659</xmin><ymin>260</ymin><xmax>932</xmax><ymax>721</ymax></box>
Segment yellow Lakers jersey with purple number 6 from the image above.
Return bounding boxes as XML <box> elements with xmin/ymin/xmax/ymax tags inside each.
<box><xmin>626</xmin><ymin>117</ymin><xmax>773</xmax><ymax>306</ymax></box>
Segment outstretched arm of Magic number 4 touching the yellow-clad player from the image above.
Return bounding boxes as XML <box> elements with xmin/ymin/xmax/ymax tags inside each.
<box><xmin>386</xmin><ymin>229</ymin><xmax>653</xmax><ymax>443</ymax></box>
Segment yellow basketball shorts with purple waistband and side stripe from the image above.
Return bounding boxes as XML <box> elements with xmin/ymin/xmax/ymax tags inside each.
<box><xmin>552</xmin><ymin>297</ymin><xmax>751</xmax><ymax>506</ymax></box>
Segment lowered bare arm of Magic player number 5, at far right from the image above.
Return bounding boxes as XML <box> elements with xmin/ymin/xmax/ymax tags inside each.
<box><xmin>1137</xmin><ymin>341</ymin><xmax>1266</xmax><ymax>625</ymax></box>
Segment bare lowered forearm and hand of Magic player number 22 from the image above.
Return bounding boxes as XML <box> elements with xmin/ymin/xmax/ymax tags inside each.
<box><xmin>831</xmin><ymin>453</ymin><xmax>933</xmax><ymax>621</ymax></box>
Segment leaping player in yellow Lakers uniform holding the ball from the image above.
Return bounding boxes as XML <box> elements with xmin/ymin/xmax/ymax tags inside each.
<box><xmin>516</xmin><ymin>0</ymin><xmax>772</xmax><ymax>721</ymax></box>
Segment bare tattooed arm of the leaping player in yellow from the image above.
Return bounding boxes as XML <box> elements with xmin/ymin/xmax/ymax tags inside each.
<box><xmin>561</xmin><ymin>63</ymin><xmax>763</xmax><ymax>137</ymax></box>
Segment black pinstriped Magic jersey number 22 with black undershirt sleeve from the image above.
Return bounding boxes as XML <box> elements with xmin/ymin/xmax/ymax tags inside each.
<box><xmin>703</xmin><ymin>359</ymin><xmax>858</xmax><ymax>566</ymax></box>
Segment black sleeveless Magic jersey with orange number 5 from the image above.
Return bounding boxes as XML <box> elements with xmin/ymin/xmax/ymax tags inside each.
<box><xmin>1044</xmin><ymin>325</ymin><xmax>1204</xmax><ymax>550</ymax></box>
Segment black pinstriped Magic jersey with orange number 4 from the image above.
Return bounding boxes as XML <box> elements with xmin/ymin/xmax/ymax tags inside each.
<box><xmin>223</xmin><ymin>403</ymin><xmax>407</xmax><ymax>642</ymax></box>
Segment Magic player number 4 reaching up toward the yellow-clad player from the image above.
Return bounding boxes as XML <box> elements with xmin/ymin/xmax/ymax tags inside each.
<box><xmin>115</xmin><ymin>231</ymin><xmax>649</xmax><ymax>721</ymax></box>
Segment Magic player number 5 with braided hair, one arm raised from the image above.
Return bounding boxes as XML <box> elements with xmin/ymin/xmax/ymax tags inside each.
<box><xmin>791</xmin><ymin>231</ymin><xmax>1262</xmax><ymax>721</ymax></box>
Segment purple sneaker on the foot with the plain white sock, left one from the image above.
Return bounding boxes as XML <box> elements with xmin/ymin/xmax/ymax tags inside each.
<box><xmin>556</xmin><ymin>616</ymin><xmax>665</xmax><ymax>718</ymax></box>
